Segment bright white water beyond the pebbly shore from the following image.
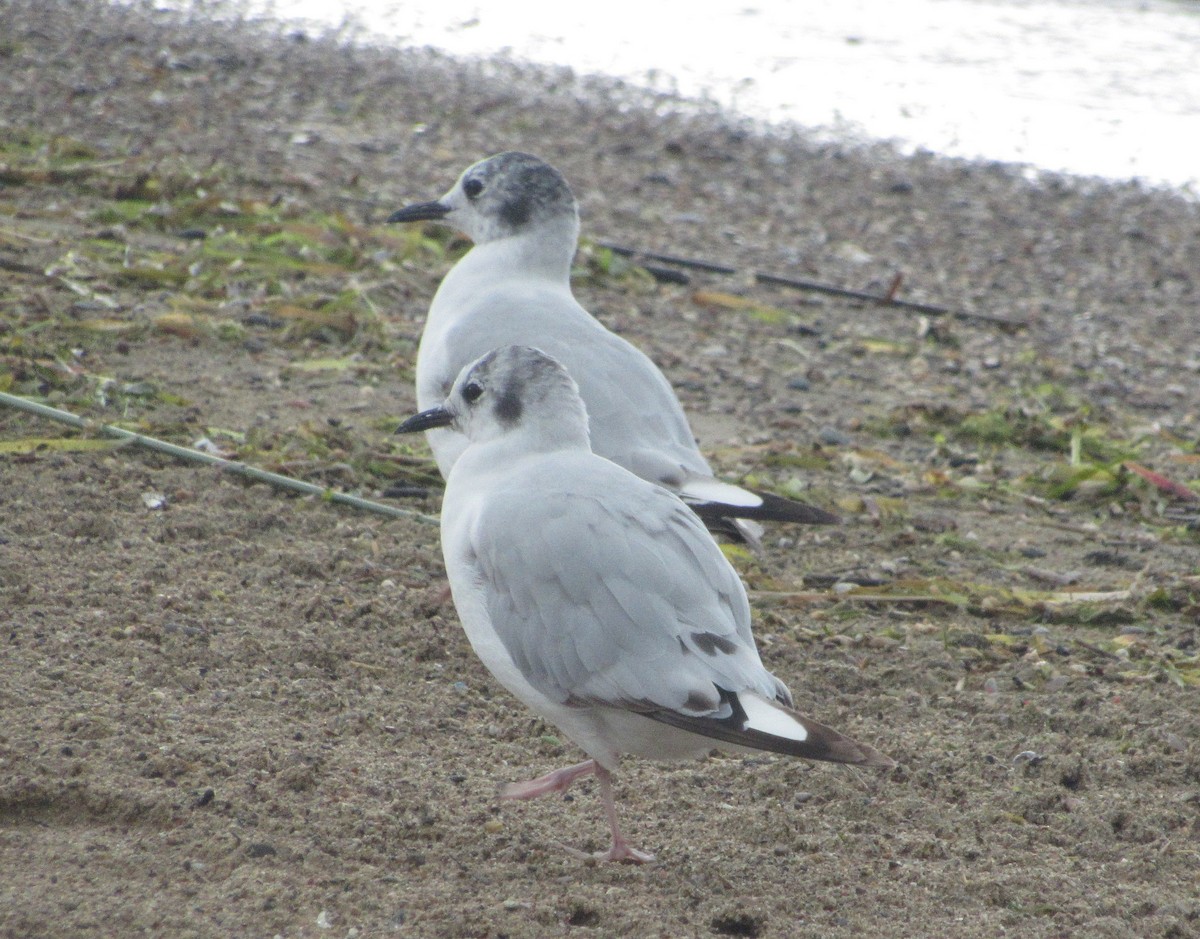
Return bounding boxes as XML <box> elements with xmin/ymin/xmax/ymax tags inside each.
<box><xmin>225</xmin><ymin>0</ymin><xmax>1200</xmax><ymax>195</ymax></box>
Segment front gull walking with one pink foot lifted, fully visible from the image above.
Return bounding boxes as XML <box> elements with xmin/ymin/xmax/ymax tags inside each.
<box><xmin>397</xmin><ymin>346</ymin><xmax>894</xmax><ymax>862</ymax></box>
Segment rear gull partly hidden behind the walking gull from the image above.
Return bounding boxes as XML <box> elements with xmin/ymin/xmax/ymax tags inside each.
<box><xmin>388</xmin><ymin>151</ymin><xmax>839</xmax><ymax>544</ymax></box>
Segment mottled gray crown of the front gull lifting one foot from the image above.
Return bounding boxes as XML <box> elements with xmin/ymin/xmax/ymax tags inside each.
<box><xmin>460</xmin><ymin>346</ymin><xmax>580</xmax><ymax>427</ymax></box>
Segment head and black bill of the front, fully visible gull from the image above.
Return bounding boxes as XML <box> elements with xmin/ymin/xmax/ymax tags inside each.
<box><xmin>396</xmin><ymin>346</ymin><xmax>589</xmax><ymax>450</ymax></box>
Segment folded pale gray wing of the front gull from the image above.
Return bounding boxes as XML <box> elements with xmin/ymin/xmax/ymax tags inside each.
<box><xmin>463</xmin><ymin>456</ymin><xmax>787</xmax><ymax>713</ymax></box>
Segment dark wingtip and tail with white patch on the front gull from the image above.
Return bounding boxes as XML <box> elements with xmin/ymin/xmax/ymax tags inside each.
<box><xmin>646</xmin><ymin>688</ymin><xmax>896</xmax><ymax>770</ymax></box>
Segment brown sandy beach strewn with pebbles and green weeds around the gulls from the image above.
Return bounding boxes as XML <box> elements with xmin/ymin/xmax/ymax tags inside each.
<box><xmin>0</xmin><ymin>0</ymin><xmax>1200</xmax><ymax>939</ymax></box>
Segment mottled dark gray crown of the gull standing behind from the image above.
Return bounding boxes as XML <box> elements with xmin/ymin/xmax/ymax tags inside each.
<box><xmin>460</xmin><ymin>150</ymin><xmax>576</xmax><ymax>229</ymax></box>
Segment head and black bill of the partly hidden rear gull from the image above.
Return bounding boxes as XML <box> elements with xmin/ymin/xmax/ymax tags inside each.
<box><xmin>388</xmin><ymin>150</ymin><xmax>578</xmax><ymax>244</ymax></box>
